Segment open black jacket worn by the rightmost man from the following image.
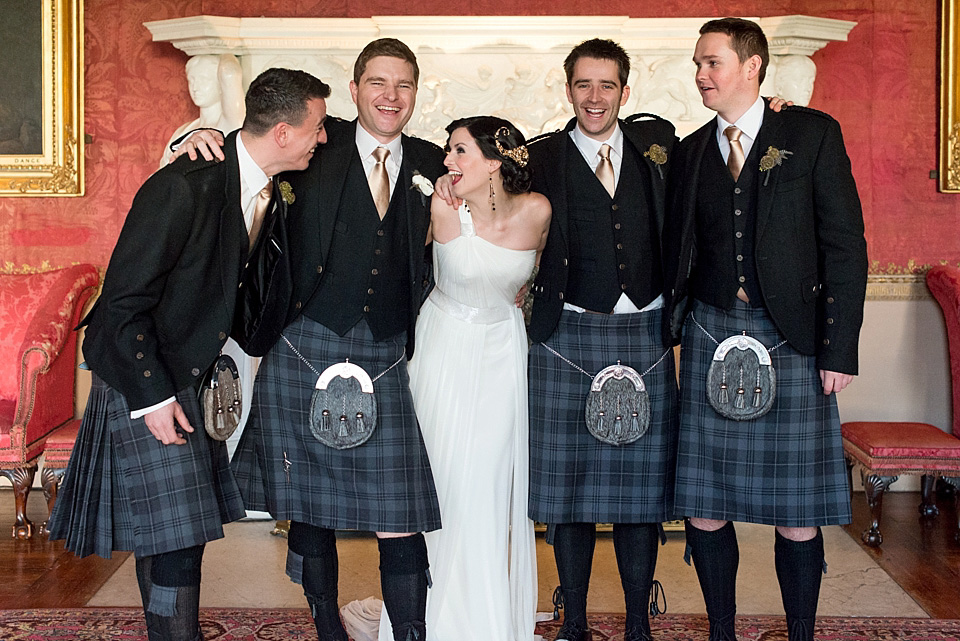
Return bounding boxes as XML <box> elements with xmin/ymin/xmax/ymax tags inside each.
<box><xmin>665</xmin><ymin>107</ymin><xmax>867</xmax><ymax>374</ymax></box>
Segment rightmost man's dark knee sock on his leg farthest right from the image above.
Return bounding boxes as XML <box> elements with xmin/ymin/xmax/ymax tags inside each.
<box><xmin>773</xmin><ymin>528</ymin><xmax>823</xmax><ymax>641</ymax></box>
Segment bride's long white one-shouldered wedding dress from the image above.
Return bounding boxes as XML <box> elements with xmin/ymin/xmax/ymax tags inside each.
<box><xmin>380</xmin><ymin>205</ymin><xmax>537</xmax><ymax>641</ymax></box>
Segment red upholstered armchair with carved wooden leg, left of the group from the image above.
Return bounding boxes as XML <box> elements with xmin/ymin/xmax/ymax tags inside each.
<box><xmin>0</xmin><ymin>265</ymin><xmax>100</xmax><ymax>539</ymax></box>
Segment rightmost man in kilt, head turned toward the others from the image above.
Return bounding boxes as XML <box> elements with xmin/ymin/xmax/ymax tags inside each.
<box><xmin>666</xmin><ymin>18</ymin><xmax>867</xmax><ymax>641</ymax></box>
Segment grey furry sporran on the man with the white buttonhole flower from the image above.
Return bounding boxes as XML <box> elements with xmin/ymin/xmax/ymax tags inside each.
<box><xmin>310</xmin><ymin>361</ymin><xmax>377</xmax><ymax>450</ymax></box>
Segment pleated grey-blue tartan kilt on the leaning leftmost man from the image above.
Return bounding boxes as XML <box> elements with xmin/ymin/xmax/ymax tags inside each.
<box><xmin>50</xmin><ymin>374</ymin><xmax>244</xmax><ymax>558</ymax></box>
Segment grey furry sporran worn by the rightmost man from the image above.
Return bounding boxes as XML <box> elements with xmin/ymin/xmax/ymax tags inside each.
<box><xmin>707</xmin><ymin>335</ymin><xmax>777</xmax><ymax>421</ymax></box>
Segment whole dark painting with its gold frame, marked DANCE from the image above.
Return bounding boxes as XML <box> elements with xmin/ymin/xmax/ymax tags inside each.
<box><xmin>0</xmin><ymin>0</ymin><xmax>83</xmax><ymax>197</ymax></box>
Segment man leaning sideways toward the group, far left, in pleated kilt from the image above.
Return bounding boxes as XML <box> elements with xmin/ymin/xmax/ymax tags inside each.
<box><xmin>51</xmin><ymin>69</ymin><xmax>330</xmax><ymax>641</ymax></box>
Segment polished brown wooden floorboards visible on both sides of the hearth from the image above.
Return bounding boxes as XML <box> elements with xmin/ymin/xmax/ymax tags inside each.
<box><xmin>0</xmin><ymin>488</ymin><xmax>960</xmax><ymax>619</ymax></box>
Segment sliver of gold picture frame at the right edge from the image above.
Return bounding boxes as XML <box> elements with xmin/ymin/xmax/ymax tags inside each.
<box><xmin>939</xmin><ymin>0</ymin><xmax>960</xmax><ymax>193</ymax></box>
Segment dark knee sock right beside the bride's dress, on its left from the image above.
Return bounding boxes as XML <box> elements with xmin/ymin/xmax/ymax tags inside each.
<box><xmin>377</xmin><ymin>533</ymin><xmax>430</xmax><ymax>641</ymax></box>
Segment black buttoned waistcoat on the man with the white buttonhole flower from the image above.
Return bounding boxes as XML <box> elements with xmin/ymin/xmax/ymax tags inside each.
<box><xmin>303</xmin><ymin>153</ymin><xmax>410</xmax><ymax>340</ymax></box>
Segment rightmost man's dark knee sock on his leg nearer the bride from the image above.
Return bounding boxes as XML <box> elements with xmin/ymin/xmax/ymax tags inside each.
<box><xmin>686</xmin><ymin>521</ymin><xmax>740</xmax><ymax>641</ymax></box>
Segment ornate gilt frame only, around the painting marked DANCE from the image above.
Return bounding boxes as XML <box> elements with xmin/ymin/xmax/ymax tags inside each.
<box><xmin>0</xmin><ymin>0</ymin><xmax>83</xmax><ymax>196</ymax></box>
